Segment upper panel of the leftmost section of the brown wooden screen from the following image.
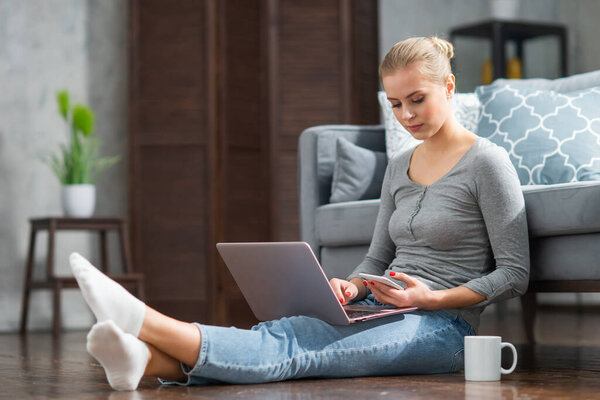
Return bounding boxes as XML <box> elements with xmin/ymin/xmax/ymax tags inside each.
<box><xmin>134</xmin><ymin>0</ymin><xmax>207</xmax><ymax>144</ymax></box>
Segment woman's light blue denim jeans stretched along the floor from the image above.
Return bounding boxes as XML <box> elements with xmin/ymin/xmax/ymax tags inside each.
<box><xmin>160</xmin><ymin>295</ymin><xmax>474</xmax><ymax>385</ymax></box>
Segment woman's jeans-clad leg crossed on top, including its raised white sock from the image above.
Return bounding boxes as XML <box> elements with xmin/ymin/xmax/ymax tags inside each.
<box><xmin>71</xmin><ymin>256</ymin><xmax>472</xmax><ymax>384</ymax></box>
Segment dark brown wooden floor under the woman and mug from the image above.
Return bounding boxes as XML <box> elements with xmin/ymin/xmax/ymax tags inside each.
<box><xmin>0</xmin><ymin>304</ymin><xmax>600</xmax><ymax>400</ymax></box>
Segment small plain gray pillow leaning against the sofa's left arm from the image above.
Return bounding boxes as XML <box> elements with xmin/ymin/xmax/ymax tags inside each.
<box><xmin>329</xmin><ymin>137</ymin><xmax>387</xmax><ymax>203</ymax></box>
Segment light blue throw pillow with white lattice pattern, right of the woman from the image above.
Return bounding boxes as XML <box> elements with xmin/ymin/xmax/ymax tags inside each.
<box><xmin>475</xmin><ymin>85</ymin><xmax>600</xmax><ymax>185</ymax></box>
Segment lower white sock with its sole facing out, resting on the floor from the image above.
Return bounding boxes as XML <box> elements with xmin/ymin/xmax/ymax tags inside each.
<box><xmin>86</xmin><ymin>320</ymin><xmax>149</xmax><ymax>390</ymax></box>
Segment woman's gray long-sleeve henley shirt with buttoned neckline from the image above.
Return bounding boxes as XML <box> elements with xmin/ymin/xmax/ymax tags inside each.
<box><xmin>348</xmin><ymin>137</ymin><xmax>529</xmax><ymax>330</ymax></box>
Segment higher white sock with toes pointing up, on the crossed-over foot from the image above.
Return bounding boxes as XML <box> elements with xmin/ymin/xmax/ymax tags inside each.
<box><xmin>69</xmin><ymin>253</ymin><xmax>146</xmax><ymax>337</ymax></box>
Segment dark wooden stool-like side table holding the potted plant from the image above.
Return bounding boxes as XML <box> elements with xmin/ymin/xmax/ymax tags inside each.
<box><xmin>20</xmin><ymin>217</ymin><xmax>145</xmax><ymax>335</ymax></box>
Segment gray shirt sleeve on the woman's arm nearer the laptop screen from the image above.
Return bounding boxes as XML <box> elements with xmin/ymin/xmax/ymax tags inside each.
<box><xmin>346</xmin><ymin>162</ymin><xmax>396</xmax><ymax>280</ymax></box>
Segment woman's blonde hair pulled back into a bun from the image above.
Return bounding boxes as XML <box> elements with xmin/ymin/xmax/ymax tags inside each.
<box><xmin>379</xmin><ymin>36</ymin><xmax>454</xmax><ymax>84</ymax></box>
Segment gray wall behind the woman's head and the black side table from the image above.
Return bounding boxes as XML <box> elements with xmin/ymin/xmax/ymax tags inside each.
<box><xmin>379</xmin><ymin>0</ymin><xmax>600</xmax><ymax>310</ymax></box>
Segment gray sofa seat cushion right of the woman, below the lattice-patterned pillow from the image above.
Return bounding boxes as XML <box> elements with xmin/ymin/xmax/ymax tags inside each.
<box><xmin>521</xmin><ymin>181</ymin><xmax>600</xmax><ymax>237</ymax></box>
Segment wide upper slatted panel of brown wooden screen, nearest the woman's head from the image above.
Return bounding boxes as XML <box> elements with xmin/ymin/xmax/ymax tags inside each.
<box><xmin>272</xmin><ymin>0</ymin><xmax>342</xmax><ymax>139</ymax></box>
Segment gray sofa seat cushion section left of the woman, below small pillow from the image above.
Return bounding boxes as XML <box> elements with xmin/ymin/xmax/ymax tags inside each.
<box><xmin>315</xmin><ymin>199</ymin><xmax>380</xmax><ymax>246</ymax></box>
